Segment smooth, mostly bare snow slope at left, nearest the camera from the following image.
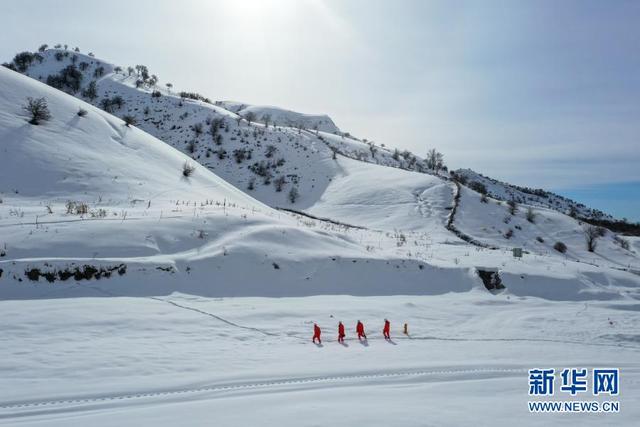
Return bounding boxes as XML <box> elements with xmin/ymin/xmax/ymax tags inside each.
<box><xmin>0</xmin><ymin>68</ymin><xmax>462</xmax><ymax>297</ymax></box>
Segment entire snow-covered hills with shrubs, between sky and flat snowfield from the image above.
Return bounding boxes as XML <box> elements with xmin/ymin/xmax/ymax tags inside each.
<box><xmin>0</xmin><ymin>49</ymin><xmax>638</xmax><ymax>304</ymax></box>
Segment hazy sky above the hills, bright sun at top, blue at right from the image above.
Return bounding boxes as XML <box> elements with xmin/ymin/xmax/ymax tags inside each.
<box><xmin>0</xmin><ymin>0</ymin><xmax>640</xmax><ymax>221</ymax></box>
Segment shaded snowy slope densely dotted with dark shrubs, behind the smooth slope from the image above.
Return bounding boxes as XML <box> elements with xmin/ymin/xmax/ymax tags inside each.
<box><xmin>13</xmin><ymin>49</ymin><xmax>436</xmax><ymax>209</ymax></box>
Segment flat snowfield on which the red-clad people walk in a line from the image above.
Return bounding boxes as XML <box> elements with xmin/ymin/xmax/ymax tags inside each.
<box><xmin>0</xmin><ymin>294</ymin><xmax>640</xmax><ymax>426</ymax></box>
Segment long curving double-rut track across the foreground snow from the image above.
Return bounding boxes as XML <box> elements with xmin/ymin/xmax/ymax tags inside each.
<box><xmin>0</xmin><ymin>368</ymin><xmax>527</xmax><ymax>419</ymax></box>
